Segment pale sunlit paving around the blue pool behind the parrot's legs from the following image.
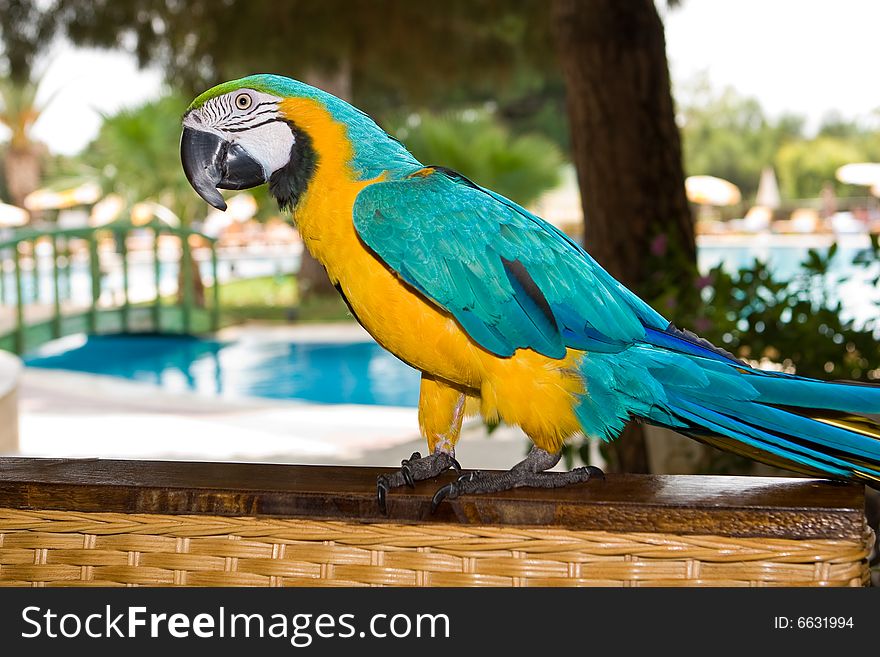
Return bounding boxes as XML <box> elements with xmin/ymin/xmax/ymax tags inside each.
<box><xmin>19</xmin><ymin>324</ymin><xmax>548</xmax><ymax>469</ymax></box>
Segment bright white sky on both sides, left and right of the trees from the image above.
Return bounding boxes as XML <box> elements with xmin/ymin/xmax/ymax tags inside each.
<box><xmin>10</xmin><ymin>0</ymin><xmax>880</xmax><ymax>154</ymax></box>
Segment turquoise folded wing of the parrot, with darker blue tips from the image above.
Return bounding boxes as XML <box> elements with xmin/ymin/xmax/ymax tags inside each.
<box><xmin>354</xmin><ymin>168</ymin><xmax>668</xmax><ymax>358</ymax></box>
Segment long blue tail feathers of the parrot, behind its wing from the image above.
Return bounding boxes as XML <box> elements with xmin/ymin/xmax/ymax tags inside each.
<box><xmin>577</xmin><ymin>330</ymin><xmax>880</xmax><ymax>487</ymax></box>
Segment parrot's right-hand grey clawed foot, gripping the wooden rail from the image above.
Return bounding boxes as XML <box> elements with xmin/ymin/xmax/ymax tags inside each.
<box><xmin>431</xmin><ymin>447</ymin><xmax>605</xmax><ymax>513</ymax></box>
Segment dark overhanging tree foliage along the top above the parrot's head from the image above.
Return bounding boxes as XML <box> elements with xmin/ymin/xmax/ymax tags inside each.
<box><xmin>36</xmin><ymin>0</ymin><xmax>556</xmax><ymax>112</ymax></box>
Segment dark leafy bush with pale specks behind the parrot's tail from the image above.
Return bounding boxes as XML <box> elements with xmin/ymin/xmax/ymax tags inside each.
<box><xmin>649</xmin><ymin>237</ymin><xmax>880</xmax><ymax>380</ymax></box>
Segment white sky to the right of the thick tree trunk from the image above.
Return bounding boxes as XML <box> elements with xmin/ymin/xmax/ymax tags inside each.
<box><xmin>662</xmin><ymin>0</ymin><xmax>880</xmax><ymax>128</ymax></box>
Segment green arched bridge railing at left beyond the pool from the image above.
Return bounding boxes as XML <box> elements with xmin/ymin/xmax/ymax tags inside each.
<box><xmin>0</xmin><ymin>220</ymin><xmax>220</xmax><ymax>354</ymax></box>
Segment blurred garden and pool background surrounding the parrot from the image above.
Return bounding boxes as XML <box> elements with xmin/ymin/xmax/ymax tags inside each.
<box><xmin>0</xmin><ymin>0</ymin><xmax>880</xmax><ymax>486</ymax></box>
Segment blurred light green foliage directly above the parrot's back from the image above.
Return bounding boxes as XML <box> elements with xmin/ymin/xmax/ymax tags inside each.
<box><xmin>396</xmin><ymin>110</ymin><xmax>562</xmax><ymax>204</ymax></box>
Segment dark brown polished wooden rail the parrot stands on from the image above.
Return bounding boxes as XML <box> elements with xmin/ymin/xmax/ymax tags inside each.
<box><xmin>0</xmin><ymin>457</ymin><xmax>865</xmax><ymax>538</ymax></box>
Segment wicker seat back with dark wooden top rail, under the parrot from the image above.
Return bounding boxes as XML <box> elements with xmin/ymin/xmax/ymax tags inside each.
<box><xmin>0</xmin><ymin>458</ymin><xmax>871</xmax><ymax>586</ymax></box>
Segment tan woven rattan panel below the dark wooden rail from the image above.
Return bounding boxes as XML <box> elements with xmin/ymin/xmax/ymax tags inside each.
<box><xmin>0</xmin><ymin>508</ymin><xmax>871</xmax><ymax>586</ymax></box>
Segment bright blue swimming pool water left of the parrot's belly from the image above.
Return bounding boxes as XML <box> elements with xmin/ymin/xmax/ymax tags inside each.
<box><xmin>23</xmin><ymin>335</ymin><xmax>419</xmax><ymax>406</ymax></box>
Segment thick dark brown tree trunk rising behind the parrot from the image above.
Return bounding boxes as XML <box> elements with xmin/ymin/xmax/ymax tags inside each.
<box><xmin>553</xmin><ymin>0</ymin><xmax>696</xmax><ymax>472</ymax></box>
